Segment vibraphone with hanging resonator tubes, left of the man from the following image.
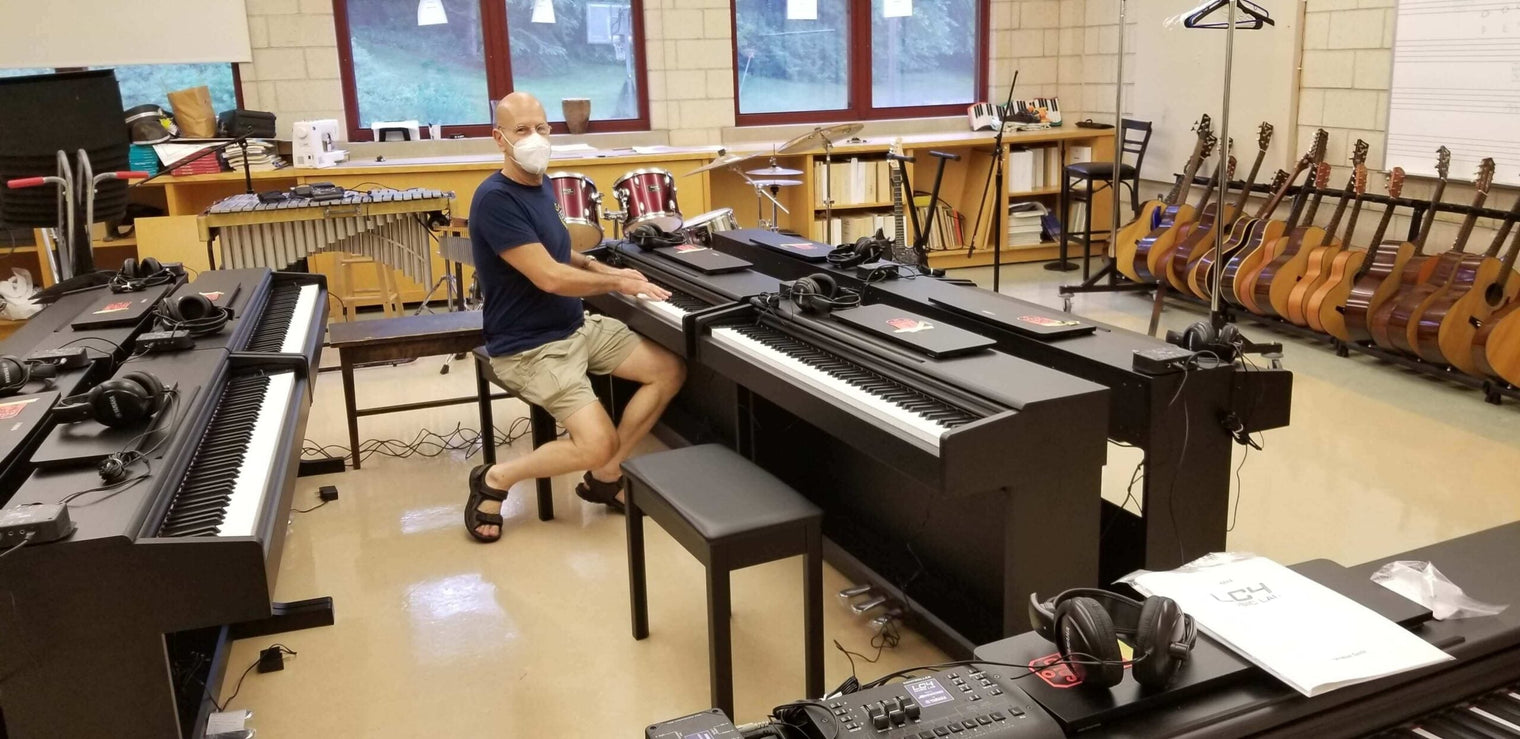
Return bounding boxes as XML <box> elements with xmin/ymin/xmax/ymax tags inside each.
<box><xmin>196</xmin><ymin>189</ymin><xmax>454</xmax><ymax>286</ymax></box>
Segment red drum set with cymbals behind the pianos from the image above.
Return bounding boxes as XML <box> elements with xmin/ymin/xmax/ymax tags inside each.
<box><xmin>549</xmin><ymin>123</ymin><xmax>862</xmax><ymax>251</ymax></box>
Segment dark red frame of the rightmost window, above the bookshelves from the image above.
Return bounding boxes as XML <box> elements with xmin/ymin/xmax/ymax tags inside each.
<box><xmin>728</xmin><ymin>0</ymin><xmax>993</xmax><ymax>126</ymax></box>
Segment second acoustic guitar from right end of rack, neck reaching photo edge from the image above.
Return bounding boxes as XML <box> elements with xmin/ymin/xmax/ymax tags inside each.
<box><xmin>1415</xmin><ymin>198</ymin><xmax>1520</xmax><ymax>374</ymax></box>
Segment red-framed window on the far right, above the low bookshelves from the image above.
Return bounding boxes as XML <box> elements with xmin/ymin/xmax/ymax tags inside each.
<box><xmin>733</xmin><ymin>0</ymin><xmax>988</xmax><ymax>125</ymax></box>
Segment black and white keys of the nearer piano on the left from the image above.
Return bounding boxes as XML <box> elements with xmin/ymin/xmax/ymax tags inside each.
<box><xmin>158</xmin><ymin>374</ymin><xmax>269</xmax><ymax>537</ymax></box>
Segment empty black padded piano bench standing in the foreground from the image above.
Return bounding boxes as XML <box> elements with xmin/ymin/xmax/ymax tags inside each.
<box><xmin>623</xmin><ymin>444</ymin><xmax>824</xmax><ymax>716</ymax></box>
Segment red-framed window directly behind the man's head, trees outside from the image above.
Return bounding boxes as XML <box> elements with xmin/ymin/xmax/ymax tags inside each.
<box><xmin>333</xmin><ymin>0</ymin><xmax>649</xmax><ymax>140</ymax></box>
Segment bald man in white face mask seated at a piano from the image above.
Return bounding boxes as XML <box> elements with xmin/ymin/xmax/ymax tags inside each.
<box><xmin>465</xmin><ymin>93</ymin><xmax>686</xmax><ymax>541</ymax></box>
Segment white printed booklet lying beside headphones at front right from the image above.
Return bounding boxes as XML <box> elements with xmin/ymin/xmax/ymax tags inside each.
<box><xmin>1134</xmin><ymin>553</ymin><xmax>1452</xmax><ymax>696</ymax></box>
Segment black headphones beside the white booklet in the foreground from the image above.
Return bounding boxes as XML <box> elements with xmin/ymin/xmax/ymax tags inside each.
<box><xmin>1029</xmin><ymin>587</ymin><xmax>1198</xmax><ymax>690</ymax></box>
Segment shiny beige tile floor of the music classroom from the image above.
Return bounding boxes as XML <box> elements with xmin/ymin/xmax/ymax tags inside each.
<box><xmin>222</xmin><ymin>266</ymin><xmax>1520</xmax><ymax>737</ymax></box>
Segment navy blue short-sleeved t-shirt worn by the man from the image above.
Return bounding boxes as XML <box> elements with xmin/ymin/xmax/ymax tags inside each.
<box><xmin>470</xmin><ymin>172</ymin><xmax>585</xmax><ymax>357</ymax></box>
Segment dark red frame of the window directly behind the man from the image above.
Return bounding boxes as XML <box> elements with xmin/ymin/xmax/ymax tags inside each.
<box><xmin>333</xmin><ymin>0</ymin><xmax>650</xmax><ymax>141</ymax></box>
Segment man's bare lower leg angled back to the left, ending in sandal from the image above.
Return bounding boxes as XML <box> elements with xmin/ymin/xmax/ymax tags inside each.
<box><xmin>476</xmin><ymin>403</ymin><xmax>617</xmax><ymax>537</ymax></box>
